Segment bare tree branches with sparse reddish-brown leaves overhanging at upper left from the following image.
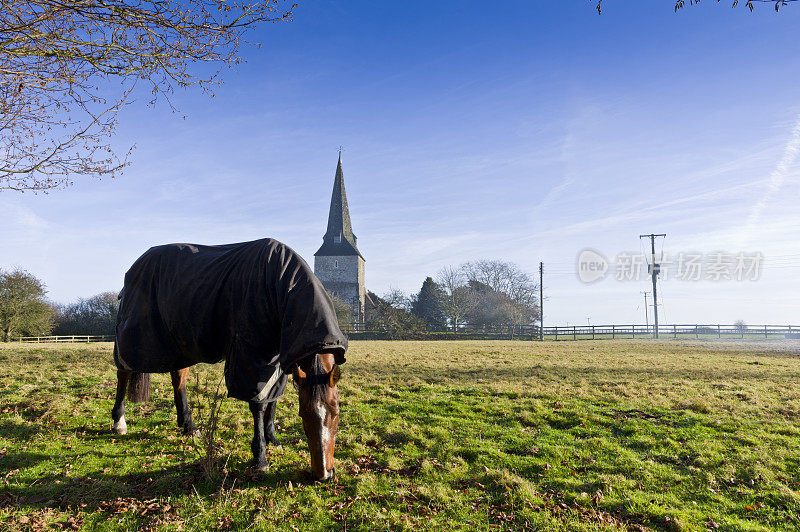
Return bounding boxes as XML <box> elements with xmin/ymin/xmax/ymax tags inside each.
<box><xmin>0</xmin><ymin>0</ymin><xmax>294</xmax><ymax>191</ymax></box>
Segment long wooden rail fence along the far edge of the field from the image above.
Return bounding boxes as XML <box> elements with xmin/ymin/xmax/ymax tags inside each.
<box><xmin>6</xmin><ymin>324</ymin><xmax>800</xmax><ymax>343</ymax></box>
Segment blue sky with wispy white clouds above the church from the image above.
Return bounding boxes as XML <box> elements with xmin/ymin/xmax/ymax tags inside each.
<box><xmin>0</xmin><ymin>0</ymin><xmax>800</xmax><ymax>325</ymax></box>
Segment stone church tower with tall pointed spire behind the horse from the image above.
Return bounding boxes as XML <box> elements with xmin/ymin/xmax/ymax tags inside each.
<box><xmin>314</xmin><ymin>151</ymin><xmax>365</xmax><ymax>324</ymax></box>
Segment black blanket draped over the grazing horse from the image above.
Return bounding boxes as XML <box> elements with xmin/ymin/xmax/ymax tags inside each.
<box><xmin>114</xmin><ymin>238</ymin><xmax>347</xmax><ymax>402</ymax></box>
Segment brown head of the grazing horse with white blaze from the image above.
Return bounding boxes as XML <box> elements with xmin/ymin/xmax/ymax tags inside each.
<box><xmin>292</xmin><ymin>353</ymin><xmax>341</xmax><ymax>480</ymax></box>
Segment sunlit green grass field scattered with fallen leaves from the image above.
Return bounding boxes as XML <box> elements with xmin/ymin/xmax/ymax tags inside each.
<box><xmin>0</xmin><ymin>340</ymin><xmax>800</xmax><ymax>530</ymax></box>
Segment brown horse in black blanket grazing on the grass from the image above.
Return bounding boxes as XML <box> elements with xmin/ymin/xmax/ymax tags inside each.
<box><xmin>111</xmin><ymin>239</ymin><xmax>347</xmax><ymax>480</ymax></box>
